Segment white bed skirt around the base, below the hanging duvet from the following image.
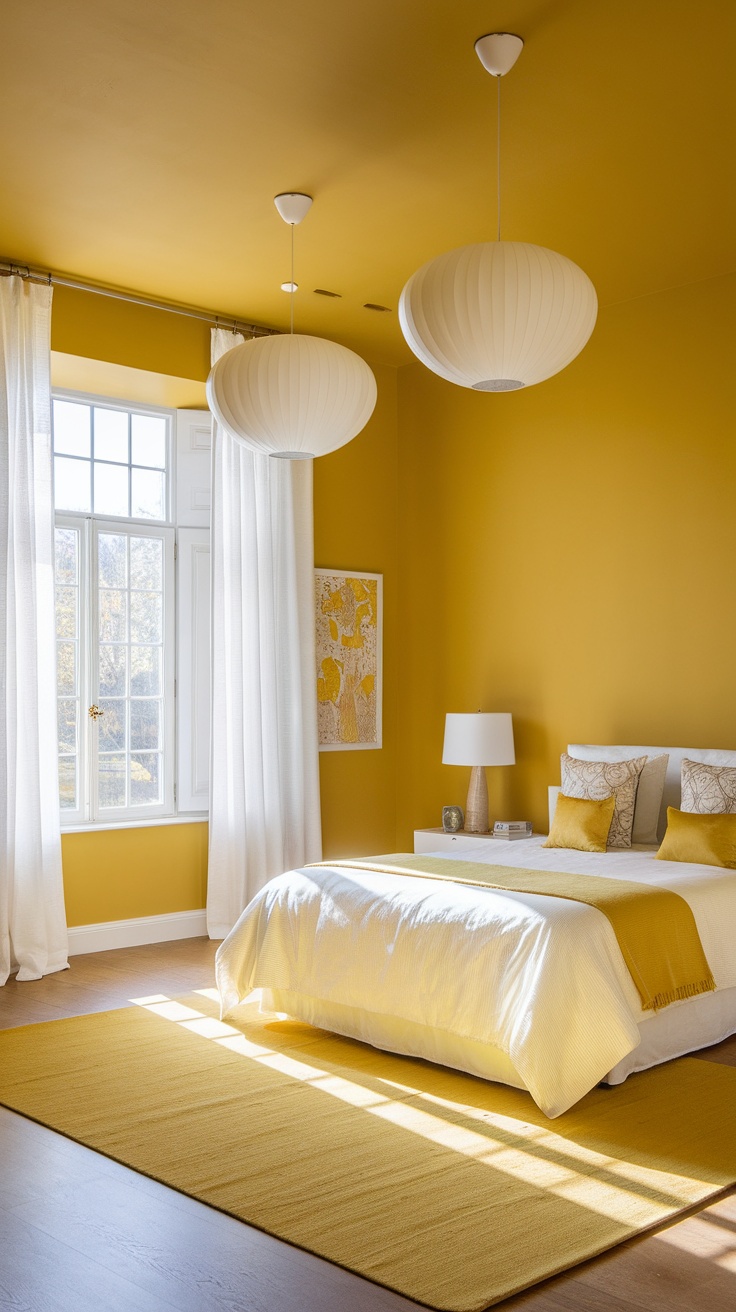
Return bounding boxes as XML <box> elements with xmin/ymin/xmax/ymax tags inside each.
<box><xmin>260</xmin><ymin>988</ymin><xmax>736</xmax><ymax>1089</ymax></box>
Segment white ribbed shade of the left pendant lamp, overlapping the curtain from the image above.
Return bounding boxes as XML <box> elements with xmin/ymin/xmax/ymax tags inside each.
<box><xmin>207</xmin><ymin>333</ymin><xmax>377</xmax><ymax>459</ymax></box>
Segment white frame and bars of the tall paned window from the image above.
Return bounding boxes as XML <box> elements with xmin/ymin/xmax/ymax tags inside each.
<box><xmin>52</xmin><ymin>388</ymin><xmax>177</xmax><ymax>829</ymax></box>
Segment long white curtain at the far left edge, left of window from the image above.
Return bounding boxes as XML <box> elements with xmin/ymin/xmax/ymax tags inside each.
<box><xmin>0</xmin><ymin>276</ymin><xmax>68</xmax><ymax>984</ymax></box>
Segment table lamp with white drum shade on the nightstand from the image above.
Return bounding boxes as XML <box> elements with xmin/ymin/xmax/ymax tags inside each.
<box><xmin>442</xmin><ymin>711</ymin><xmax>516</xmax><ymax>833</ymax></box>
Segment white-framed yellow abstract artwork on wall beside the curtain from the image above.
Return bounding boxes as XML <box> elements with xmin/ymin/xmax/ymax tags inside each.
<box><xmin>315</xmin><ymin>569</ymin><xmax>383</xmax><ymax>752</ymax></box>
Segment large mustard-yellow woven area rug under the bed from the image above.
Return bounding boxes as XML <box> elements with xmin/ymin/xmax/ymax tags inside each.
<box><xmin>0</xmin><ymin>991</ymin><xmax>736</xmax><ymax>1312</ymax></box>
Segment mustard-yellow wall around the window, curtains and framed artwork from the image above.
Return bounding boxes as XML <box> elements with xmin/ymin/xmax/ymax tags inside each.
<box><xmin>51</xmin><ymin>287</ymin><xmax>398</xmax><ymax>925</ymax></box>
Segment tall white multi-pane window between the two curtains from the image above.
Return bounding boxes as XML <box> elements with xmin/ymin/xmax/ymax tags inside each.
<box><xmin>52</xmin><ymin>396</ymin><xmax>176</xmax><ymax>824</ymax></box>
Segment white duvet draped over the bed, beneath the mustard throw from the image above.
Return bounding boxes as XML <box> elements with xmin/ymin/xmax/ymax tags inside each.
<box><xmin>216</xmin><ymin>838</ymin><xmax>736</xmax><ymax>1117</ymax></box>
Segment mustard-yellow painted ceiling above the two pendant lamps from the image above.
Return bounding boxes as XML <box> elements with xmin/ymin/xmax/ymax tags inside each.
<box><xmin>0</xmin><ymin>0</ymin><xmax>736</xmax><ymax>363</ymax></box>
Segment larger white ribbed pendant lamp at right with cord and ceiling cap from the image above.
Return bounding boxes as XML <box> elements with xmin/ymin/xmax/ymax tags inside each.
<box><xmin>399</xmin><ymin>31</ymin><xmax>598</xmax><ymax>392</ymax></box>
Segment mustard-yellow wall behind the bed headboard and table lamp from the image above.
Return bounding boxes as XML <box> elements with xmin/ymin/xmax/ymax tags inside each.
<box><xmin>398</xmin><ymin>277</ymin><xmax>736</xmax><ymax>846</ymax></box>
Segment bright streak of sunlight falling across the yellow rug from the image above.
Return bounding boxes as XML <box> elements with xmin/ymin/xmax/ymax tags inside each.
<box><xmin>130</xmin><ymin>989</ymin><xmax>718</xmax><ymax>1228</ymax></box>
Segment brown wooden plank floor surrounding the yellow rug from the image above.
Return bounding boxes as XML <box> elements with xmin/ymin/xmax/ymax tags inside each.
<box><xmin>0</xmin><ymin>938</ymin><xmax>736</xmax><ymax>1312</ymax></box>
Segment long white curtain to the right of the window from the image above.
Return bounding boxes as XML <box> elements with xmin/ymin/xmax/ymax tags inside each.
<box><xmin>207</xmin><ymin>328</ymin><xmax>321</xmax><ymax>938</ymax></box>
